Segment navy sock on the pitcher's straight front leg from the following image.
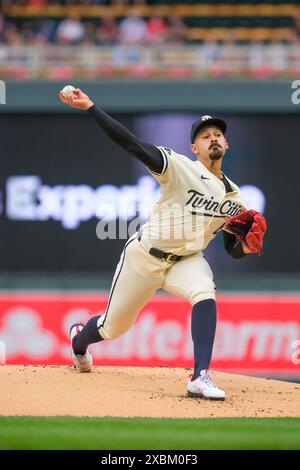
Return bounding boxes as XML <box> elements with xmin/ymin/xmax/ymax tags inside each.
<box><xmin>192</xmin><ymin>299</ymin><xmax>217</xmax><ymax>379</ymax></box>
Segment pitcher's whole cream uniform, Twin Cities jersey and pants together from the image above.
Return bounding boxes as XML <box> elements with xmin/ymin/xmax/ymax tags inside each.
<box><xmin>98</xmin><ymin>147</ymin><xmax>246</xmax><ymax>339</ymax></box>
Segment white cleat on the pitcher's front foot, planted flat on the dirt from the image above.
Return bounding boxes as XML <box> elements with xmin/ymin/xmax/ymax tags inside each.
<box><xmin>188</xmin><ymin>369</ymin><xmax>225</xmax><ymax>400</ymax></box>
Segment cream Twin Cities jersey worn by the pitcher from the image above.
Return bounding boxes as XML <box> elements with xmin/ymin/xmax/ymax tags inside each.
<box><xmin>141</xmin><ymin>147</ymin><xmax>246</xmax><ymax>255</ymax></box>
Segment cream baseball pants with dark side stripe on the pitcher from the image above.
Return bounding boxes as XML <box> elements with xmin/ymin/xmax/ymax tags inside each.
<box><xmin>98</xmin><ymin>234</ymin><xmax>215</xmax><ymax>339</ymax></box>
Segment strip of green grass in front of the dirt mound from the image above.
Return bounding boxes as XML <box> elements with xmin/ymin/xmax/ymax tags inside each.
<box><xmin>0</xmin><ymin>417</ymin><xmax>300</xmax><ymax>450</ymax></box>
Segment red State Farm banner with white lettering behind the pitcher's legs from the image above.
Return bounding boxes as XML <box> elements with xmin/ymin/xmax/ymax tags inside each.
<box><xmin>0</xmin><ymin>292</ymin><xmax>300</xmax><ymax>377</ymax></box>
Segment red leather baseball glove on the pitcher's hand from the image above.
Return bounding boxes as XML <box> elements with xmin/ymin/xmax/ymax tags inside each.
<box><xmin>223</xmin><ymin>210</ymin><xmax>267</xmax><ymax>255</ymax></box>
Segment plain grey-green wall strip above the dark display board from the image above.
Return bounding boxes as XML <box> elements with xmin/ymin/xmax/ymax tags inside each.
<box><xmin>0</xmin><ymin>76</ymin><xmax>300</xmax><ymax>113</ymax></box>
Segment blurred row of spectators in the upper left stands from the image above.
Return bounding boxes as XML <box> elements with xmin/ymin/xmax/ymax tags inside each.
<box><xmin>0</xmin><ymin>8</ymin><xmax>186</xmax><ymax>45</ymax></box>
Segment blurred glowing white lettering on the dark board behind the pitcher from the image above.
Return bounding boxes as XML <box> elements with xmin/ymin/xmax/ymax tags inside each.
<box><xmin>6</xmin><ymin>175</ymin><xmax>265</xmax><ymax>230</ymax></box>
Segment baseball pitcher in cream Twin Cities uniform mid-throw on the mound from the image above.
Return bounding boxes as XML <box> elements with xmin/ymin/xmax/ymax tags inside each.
<box><xmin>59</xmin><ymin>88</ymin><xmax>267</xmax><ymax>400</ymax></box>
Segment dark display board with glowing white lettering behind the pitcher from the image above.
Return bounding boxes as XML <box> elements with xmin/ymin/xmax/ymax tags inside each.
<box><xmin>0</xmin><ymin>111</ymin><xmax>300</xmax><ymax>277</ymax></box>
